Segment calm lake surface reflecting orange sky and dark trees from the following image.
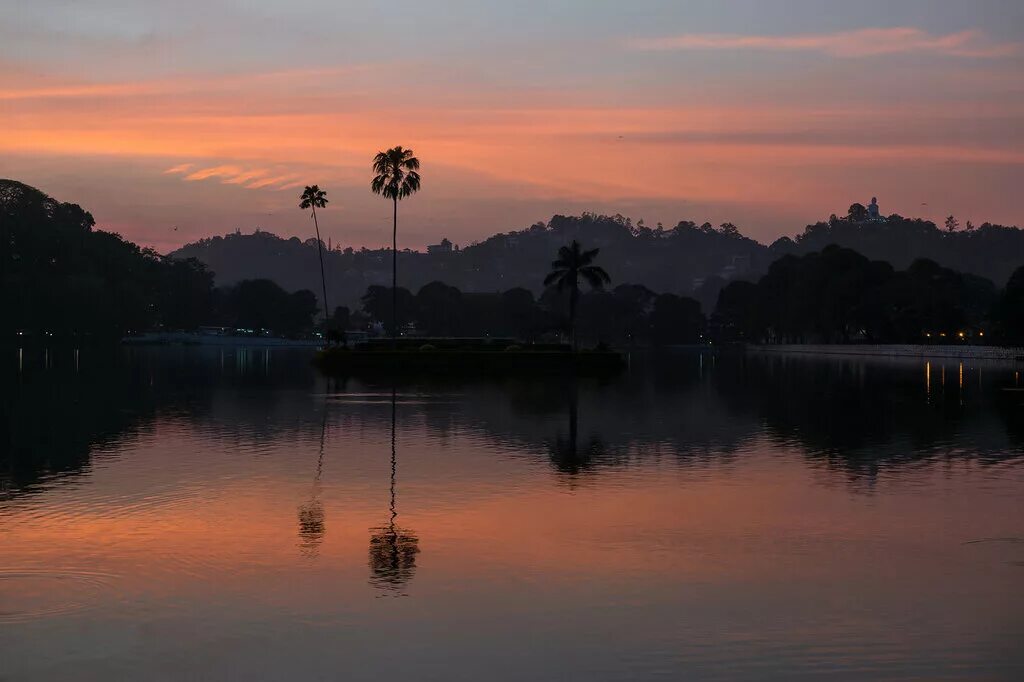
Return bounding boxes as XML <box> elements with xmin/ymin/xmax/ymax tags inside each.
<box><xmin>0</xmin><ymin>349</ymin><xmax>1024</xmax><ymax>682</ymax></box>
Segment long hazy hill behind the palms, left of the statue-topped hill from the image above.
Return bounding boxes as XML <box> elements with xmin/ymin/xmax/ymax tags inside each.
<box><xmin>170</xmin><ymin>214</ymin><xmax>771</xmax><ymax>306</ymax></box>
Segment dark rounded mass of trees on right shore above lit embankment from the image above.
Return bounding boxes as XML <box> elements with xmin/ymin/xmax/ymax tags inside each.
<box><xmin>714</xmin><ymin>246</ymin><xmax>1024</xmax><ymax>343</ymax></box>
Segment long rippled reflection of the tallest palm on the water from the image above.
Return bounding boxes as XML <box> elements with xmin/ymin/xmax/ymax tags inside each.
<box><xmin>370</xmin><ymin>388</ymin><xmax>420</xmax><ymax>596</ymax></box>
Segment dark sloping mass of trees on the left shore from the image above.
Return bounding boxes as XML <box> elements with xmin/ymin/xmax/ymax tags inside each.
<box><xmin>0</xmin><ymin>180</ymin><xmax>316</xmax><ymax>339</ymax></box>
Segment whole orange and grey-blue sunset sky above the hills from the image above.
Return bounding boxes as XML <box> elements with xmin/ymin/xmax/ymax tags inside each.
<box><xmin>0</xmin><ymin>0</ymin><xmax>1024</xmax><ymax>251</ymax></box>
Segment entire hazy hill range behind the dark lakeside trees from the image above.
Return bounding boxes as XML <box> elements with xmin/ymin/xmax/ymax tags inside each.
<box><xmin>170</xmin><ymin>213</ymin><xmax>1024</xmax><ymax>311</ymax></box>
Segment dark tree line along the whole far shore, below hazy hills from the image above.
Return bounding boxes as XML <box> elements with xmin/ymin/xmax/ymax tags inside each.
<box><xmin>0</xmin><ymin>176</ymin><xmax>1024</xmax><ymax>345</ymax></box>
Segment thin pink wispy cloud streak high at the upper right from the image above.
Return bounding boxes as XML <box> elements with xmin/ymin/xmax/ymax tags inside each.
<box><xmin>629</xmin><ymin>28</ymin><xmax>1021</xmax><ymax>58</ymax></box>
